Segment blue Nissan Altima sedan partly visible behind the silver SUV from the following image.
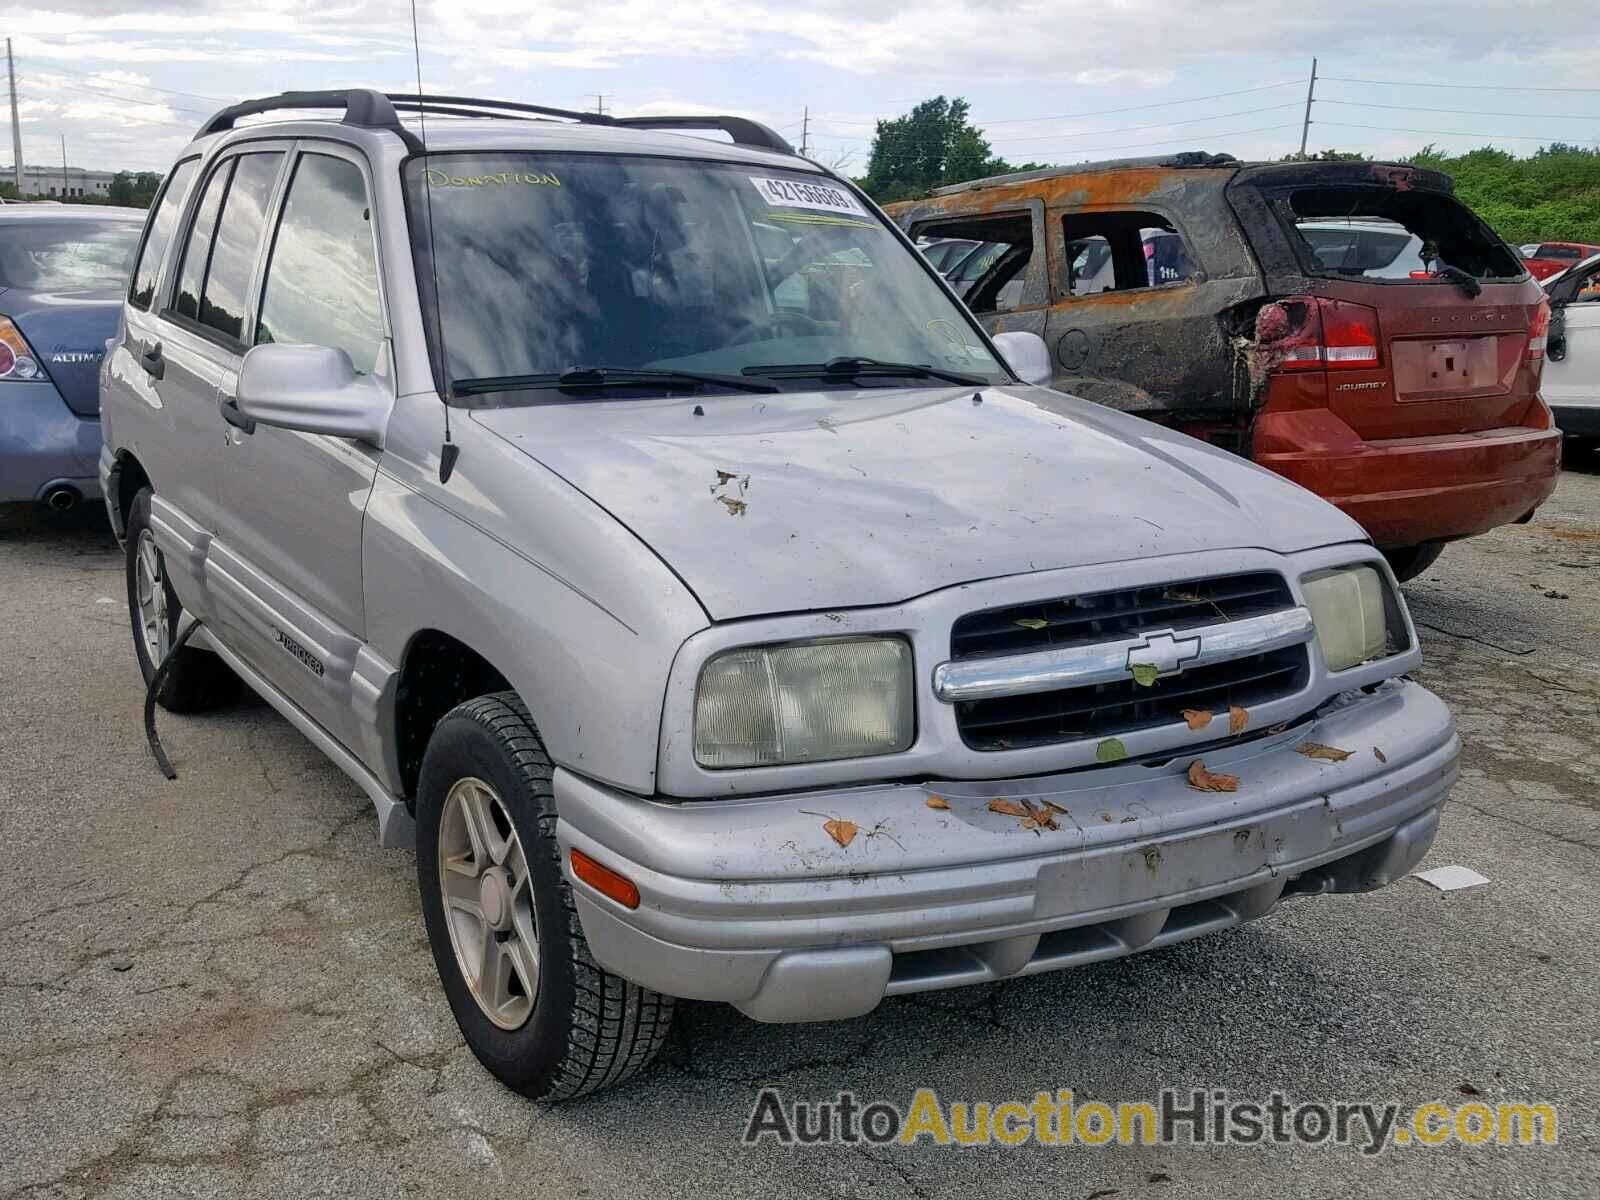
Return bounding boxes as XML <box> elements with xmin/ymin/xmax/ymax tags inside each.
<box><xmin>0</xmin><ymin>203</ymin><xmax>144</xmax><ymax>510</ymax></box>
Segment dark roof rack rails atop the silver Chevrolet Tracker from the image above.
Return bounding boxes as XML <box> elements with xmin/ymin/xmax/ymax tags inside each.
<box><xmin>195</xmin><ymin>88</ymin><xmax>794</xmax><ymax>154</ymax></box>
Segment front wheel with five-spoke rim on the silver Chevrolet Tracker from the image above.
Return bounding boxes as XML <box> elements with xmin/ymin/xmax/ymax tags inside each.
<box><xmin>416</xmin><ymin>691</ymin><xmax>674</xmax><ymax>1102</ymax></box>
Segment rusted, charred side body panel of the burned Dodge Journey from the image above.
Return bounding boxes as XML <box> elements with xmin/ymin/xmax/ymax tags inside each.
<box><xmin>890</xmin><ymin>165</ymin><xmax>1266</xmax><ymax>430</ymax></box>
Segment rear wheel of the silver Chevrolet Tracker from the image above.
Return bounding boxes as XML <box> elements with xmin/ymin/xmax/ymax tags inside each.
<box><xmin>123</xmin><ymin>488</ymin><xmax>240</xmax><ymax>712</ymax></box>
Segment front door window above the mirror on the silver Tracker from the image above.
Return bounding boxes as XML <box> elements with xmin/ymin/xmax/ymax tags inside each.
<box><xmin>256</xmin><ymin>154</ymin><xmax>384</xmax><ymax>374</ymax></box>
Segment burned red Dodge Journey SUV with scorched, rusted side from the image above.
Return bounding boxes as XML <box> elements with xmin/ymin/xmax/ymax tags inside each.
<box><xmin>890</xmin><ymin>154</ymin><xmax>1560</xmax><ymax>579</ymax></box>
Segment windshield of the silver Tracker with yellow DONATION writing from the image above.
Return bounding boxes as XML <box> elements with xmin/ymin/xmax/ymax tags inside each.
<box><xmin>406</xmin><ymin>154</ymin><xmax>1008</xmax><ymax>400</ymax></box>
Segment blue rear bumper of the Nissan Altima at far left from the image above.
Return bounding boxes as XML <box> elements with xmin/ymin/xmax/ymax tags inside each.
<box><xmin>0</xmin><ymin>382</ymin><xmax>101</xmax><ymax>504</ymax></box>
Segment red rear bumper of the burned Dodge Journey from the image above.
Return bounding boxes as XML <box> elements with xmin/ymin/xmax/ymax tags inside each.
<box><xmin>1254</xmin><ymin>410</ymin><xmax>1562</xmax><ymax>547</ymax></box>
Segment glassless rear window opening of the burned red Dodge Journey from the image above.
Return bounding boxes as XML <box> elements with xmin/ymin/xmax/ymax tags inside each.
<box><xmin>1280</xmin><ymin>186</ymin><xmax>1523</xmax><ymax>282</ymax></box>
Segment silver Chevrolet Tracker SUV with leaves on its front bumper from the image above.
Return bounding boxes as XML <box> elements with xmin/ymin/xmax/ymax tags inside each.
<box><xmin>101</xmin><ymin>91</ymin><xmax>1459</xmax><ymax>1099</ymax></box>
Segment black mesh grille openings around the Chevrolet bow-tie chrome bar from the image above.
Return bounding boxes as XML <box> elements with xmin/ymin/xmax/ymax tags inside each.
<box><xmin>950</xmin><ymin>573</ymin><xmax>1310</xmax><ymax>750</ymax></box>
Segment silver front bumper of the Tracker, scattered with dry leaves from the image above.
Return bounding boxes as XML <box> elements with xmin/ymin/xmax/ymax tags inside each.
<box><xmin>555</xmin><ymin>680</ymin><xmax>1459</xmax><ymax>1021</ymax></box>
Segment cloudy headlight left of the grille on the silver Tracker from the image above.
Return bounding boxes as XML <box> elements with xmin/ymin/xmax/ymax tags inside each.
<box><xmin>694</xmin><ymin>637</ymin><xmax>915</xmax><ymax>768</ymax></box>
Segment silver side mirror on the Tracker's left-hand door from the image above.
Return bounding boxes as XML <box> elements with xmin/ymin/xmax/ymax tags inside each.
<box><xmin>238</xmin><ymin>342</ymin><xmax>394</xmax><ymax>450</ymax></box>
